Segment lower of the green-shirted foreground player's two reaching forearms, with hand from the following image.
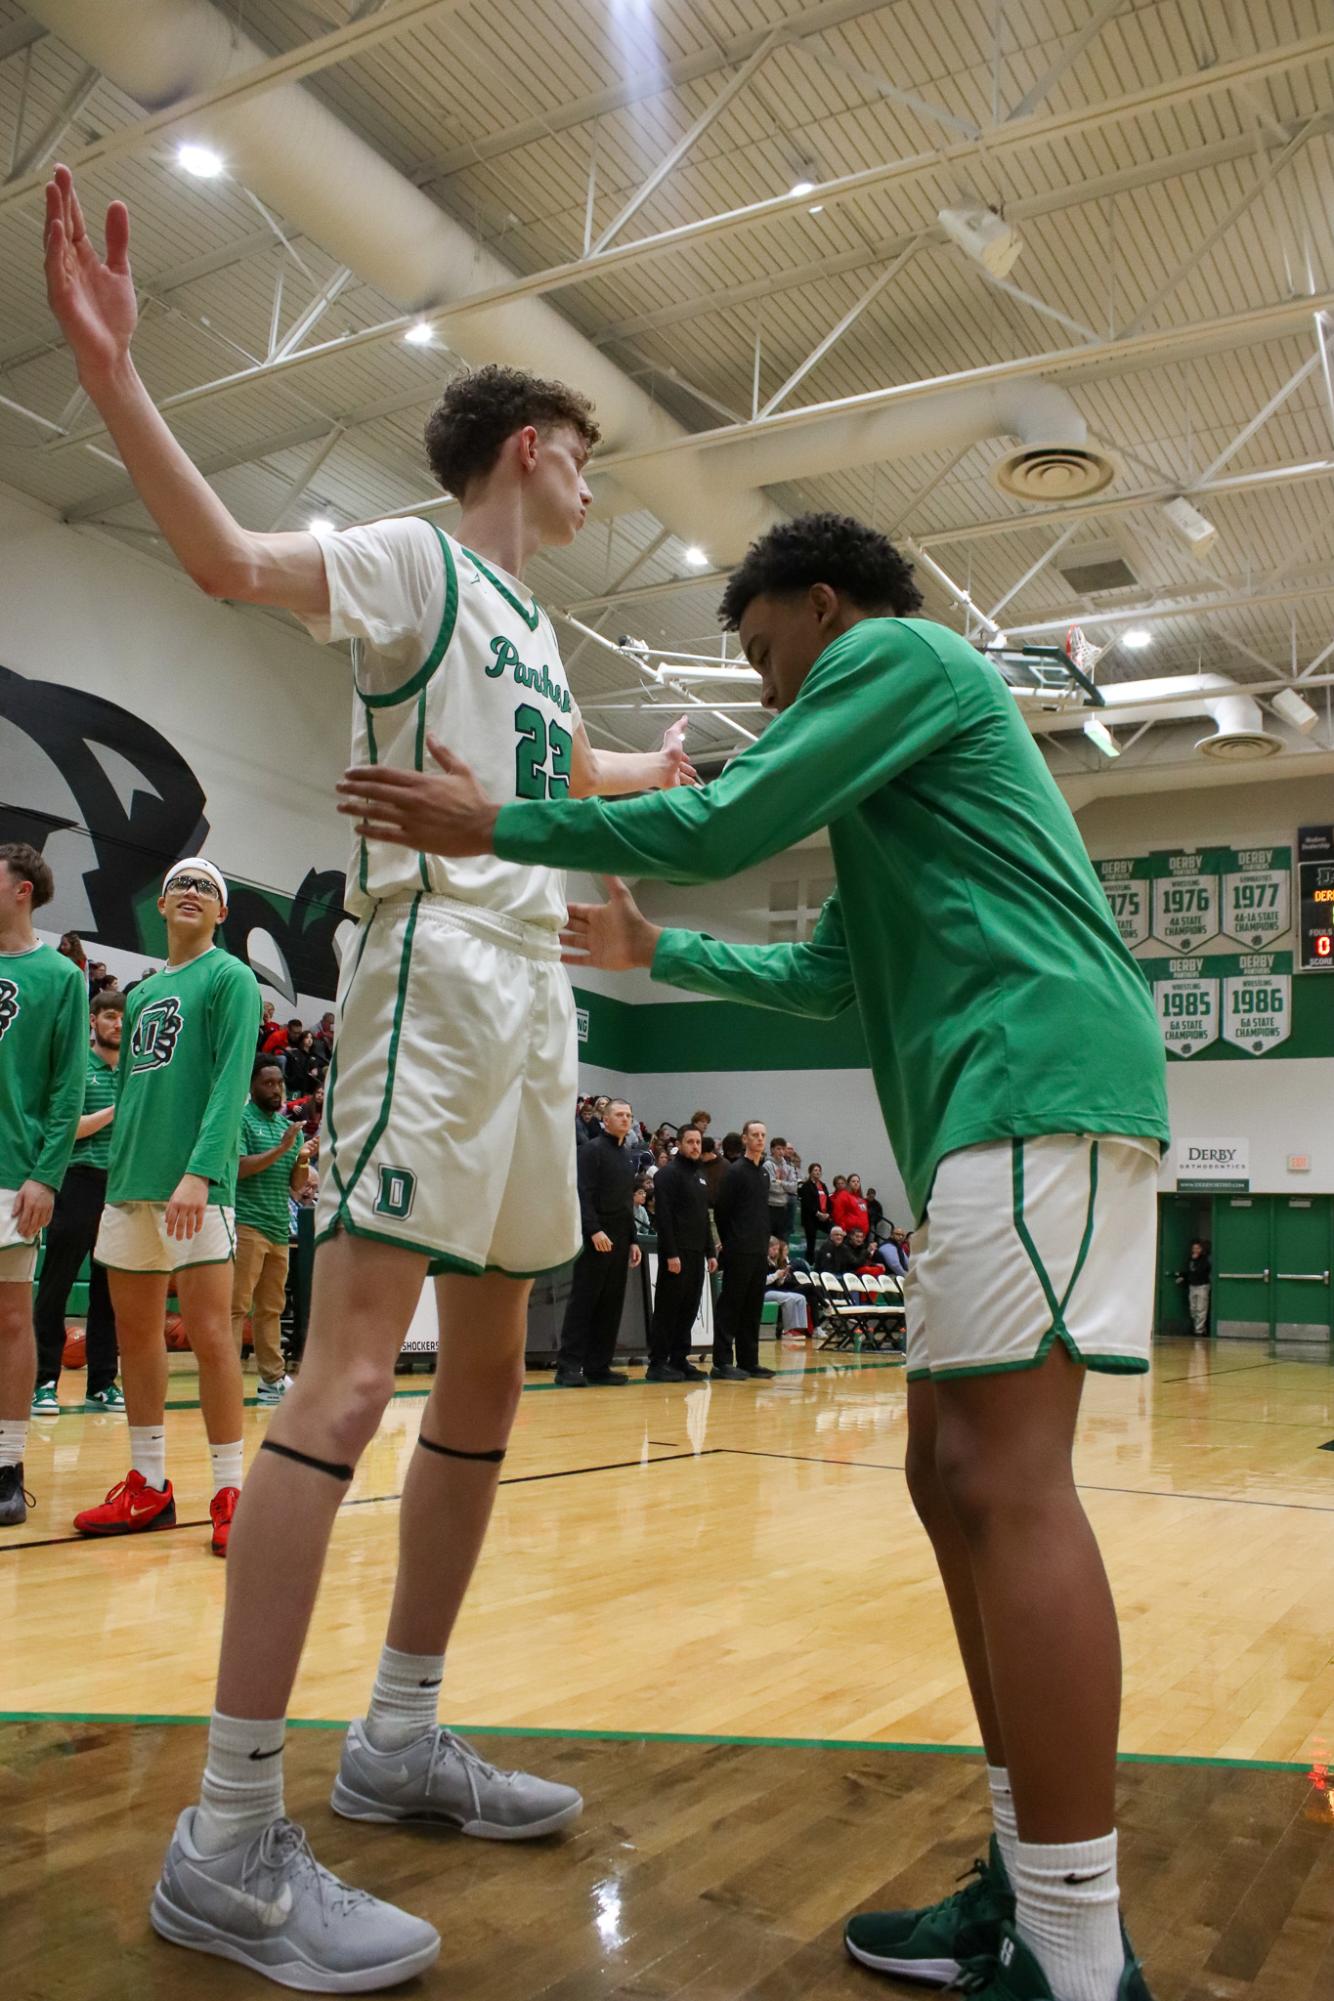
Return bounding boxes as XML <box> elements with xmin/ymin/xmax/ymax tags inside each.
<box><xmin>560</xmin><ymin>876</ymin><xmax>856</xmax><ymax>1021</ymax></box>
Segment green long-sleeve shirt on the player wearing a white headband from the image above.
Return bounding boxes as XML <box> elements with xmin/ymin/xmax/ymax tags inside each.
<box><xmin>106</xmin><ymin>946</ymin><xmax>260</xmax><ymax>1209</ymax></box>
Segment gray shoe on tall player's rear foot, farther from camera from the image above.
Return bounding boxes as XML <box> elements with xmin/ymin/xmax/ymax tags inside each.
<box><xmin>332</xmin><ymin>1723</ymin><xmax>584</xmax><ymax>1841</ymax></box>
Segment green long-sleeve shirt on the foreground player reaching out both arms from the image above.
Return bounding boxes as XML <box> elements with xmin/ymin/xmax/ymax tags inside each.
<box><xmin>496</xmin><ymin>618</ymin><xmax>1168</xmax><ymax>1217</ymax></box>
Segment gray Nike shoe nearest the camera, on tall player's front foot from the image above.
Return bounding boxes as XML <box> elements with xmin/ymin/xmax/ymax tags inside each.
<box><xmin>148</xmin><ymin>1807</ymin><xmax>440</xmax><ymax>1995</ymax></box>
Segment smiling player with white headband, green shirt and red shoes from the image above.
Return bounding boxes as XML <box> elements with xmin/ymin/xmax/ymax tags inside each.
<box><xmin>74</xmin><ymin>856</ymin><xmax>260</xmax><ymax>1557</ymax></box>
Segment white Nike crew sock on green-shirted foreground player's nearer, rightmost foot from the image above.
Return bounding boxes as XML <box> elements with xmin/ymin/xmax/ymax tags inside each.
<box><xmin>1010</xmin><ymin>1833</ymin><xmax>1126</xmax><ymax>2001</ymax></box>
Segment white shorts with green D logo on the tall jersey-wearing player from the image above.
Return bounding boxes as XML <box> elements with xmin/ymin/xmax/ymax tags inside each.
<box><xmin>316</xmin><ymin>894</ymin><xmax>582</xmax><ymax>1279</ymax></box>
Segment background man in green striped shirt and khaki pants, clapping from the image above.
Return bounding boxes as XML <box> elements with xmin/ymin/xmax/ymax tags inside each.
<box><xmin>232</xmin><ymin>1057</ymin><xmax>310</xmax><ymax>1403</ymax></box>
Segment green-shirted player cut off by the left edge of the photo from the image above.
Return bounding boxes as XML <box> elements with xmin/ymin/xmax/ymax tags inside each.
<box><xmin>0</xmin><ymin>840</ymin><xmax>88</xmax><ymax>1529</ymax></box>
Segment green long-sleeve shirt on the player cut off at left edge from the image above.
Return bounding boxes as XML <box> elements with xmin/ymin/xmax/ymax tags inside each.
<box><xmin>0</xmin><ymin>944</ymin><xmax>88</xmax><ymax>1189</ymax></box>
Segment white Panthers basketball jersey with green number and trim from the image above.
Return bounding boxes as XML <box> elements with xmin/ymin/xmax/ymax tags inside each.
<box><xmin>346</xmin><ymin>522</ymin><xmax>578</xmax><ymax>930</ymax></box>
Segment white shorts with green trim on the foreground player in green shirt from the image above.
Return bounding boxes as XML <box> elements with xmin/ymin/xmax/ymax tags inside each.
<box><xmin>904</xmin><ymin>1133</ymin><xmax>1158</xmax><ymax>1381</ymax></box>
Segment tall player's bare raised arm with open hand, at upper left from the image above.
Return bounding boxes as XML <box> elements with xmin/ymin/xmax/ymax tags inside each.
<box><xmin>44</xmin><ymin>166</ymin><xmax>328</xmax><ymax>616</ymax></box>
